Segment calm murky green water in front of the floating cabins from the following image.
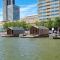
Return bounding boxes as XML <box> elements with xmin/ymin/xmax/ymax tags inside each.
<box><xmin>0</xmin><ymin>37</ymin><xmax>60</xmax><ymax>60</ymax></box>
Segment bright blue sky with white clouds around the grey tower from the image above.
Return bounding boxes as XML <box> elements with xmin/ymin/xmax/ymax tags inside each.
<box><xmin>0</xmin><ymin>0</ymin><xmax>37</xmax><ymax>21</ymax></box>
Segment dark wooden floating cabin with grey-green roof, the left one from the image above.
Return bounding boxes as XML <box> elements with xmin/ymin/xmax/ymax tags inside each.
<box><xmin>7</xmin><ymin>27</ymin><xmax>24</xmax><ymax>37</ymax></box>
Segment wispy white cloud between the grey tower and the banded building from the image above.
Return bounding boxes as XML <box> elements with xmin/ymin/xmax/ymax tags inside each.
<box><xmin>20</xmin><ymin>4</ymin><xmax>37</xmax><ymax>18</ymax></box>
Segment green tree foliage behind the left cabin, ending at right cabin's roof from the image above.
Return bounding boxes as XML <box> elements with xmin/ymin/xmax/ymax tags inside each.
<box><xmin>3</xmin><ymin>21</ymin><xmax>31</xmax><ymax>29</ymax></box>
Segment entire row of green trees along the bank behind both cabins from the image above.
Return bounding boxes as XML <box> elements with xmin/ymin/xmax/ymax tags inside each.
<box><xmin>3</xmin><ymin>17</ymin><xmax>60</xmax><ymax>29</ymax></box>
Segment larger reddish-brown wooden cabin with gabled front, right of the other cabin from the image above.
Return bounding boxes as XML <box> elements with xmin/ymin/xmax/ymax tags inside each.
<box><xmin>30</xmin><ymin>26</ymin><xmax>49</xmax><ymax>36</ymax></box>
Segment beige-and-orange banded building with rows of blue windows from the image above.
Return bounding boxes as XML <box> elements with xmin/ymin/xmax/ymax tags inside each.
<box><xmin>38</xmin><ymin>0</ymin><xmax>60</xmax><ymax>20</ymax></box>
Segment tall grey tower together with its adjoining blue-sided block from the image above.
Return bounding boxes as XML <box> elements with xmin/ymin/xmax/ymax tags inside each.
<box><xmin>3</xmin><ymin>0</ymin><xmax>20</xmax><ymax>21</ymax></box>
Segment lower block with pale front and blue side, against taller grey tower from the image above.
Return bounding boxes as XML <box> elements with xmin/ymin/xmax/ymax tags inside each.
<box><xmin>7</xmin><ymin>5</ymin><xmax>20</xmax><ymax>21</ymax></box>
